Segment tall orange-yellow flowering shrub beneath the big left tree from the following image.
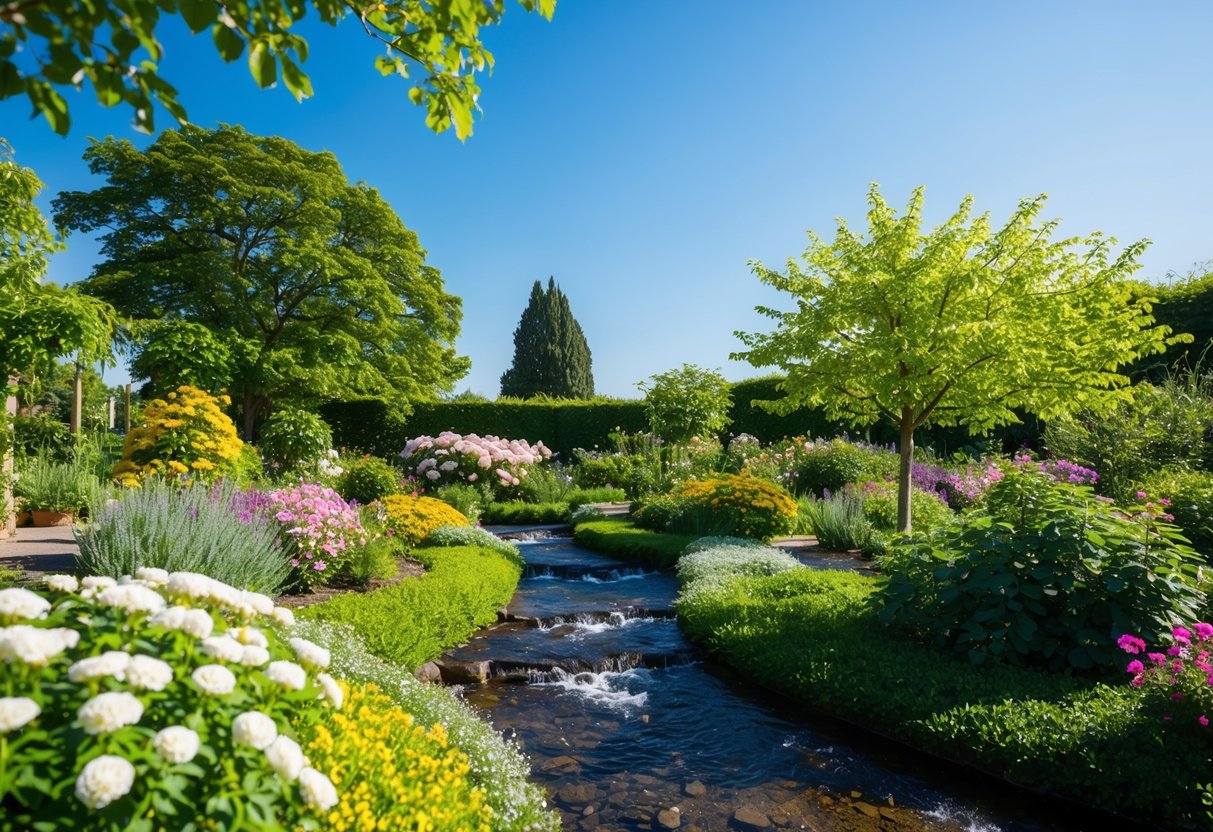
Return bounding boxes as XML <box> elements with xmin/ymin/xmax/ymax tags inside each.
<box><xmin>114</xmin><ymin>384</ymin><xmax>244</xmax><ymax>488</ymax></box>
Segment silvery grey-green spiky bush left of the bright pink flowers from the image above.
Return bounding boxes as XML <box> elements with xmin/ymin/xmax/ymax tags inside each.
<box><xmin>75</xmin><ymin>479</ymin><xmax>290</xmax><ymax>593</ymax></box>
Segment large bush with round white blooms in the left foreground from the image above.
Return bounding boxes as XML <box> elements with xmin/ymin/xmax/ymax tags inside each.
<box><xmin>0</xmin><ymin>570</ymin><xmax>340</xmax><ymax>831</ymax></box>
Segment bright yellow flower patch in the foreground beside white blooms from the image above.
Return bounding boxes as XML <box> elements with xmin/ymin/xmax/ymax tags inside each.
<box><xmin>304</xmin><ymin>683</ymin><xmax>492</xmax><ymax>832</ymax></box>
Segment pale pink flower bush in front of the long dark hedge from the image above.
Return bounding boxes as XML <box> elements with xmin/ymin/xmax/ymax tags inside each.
<box><xmin>400</xmin><ymin>431</ymin><xmax>552</xmax><ymax>489</ymax></box>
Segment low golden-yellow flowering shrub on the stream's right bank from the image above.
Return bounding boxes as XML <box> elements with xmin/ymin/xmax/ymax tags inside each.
<box><xmin>636</xmin><ymin>473</ymin><xmax>797</xmax><ymax>540</ymax></box>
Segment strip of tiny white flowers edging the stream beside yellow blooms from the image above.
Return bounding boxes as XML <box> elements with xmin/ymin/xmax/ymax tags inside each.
<box><xmin>294</xmin><ymin>621</ymin><xmax>559</xmax><ymax>832</ymax></box>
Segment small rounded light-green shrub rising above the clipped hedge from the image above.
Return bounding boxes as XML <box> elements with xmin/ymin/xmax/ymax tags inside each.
<box><xmin>637</xmin><ymin>364</ymin><xmax>733</xmax><ymax>441</ymax></box>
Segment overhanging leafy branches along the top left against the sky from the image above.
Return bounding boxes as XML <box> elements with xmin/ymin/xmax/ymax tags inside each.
<box><xmin>0</xmin><ymin>0</ymin><xmax>556</xmax><ymax>139</ymax></box>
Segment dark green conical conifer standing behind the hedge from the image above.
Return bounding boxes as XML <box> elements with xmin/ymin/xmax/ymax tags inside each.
<box><xmin>501</xmin><ymin>278</ymin><xmax>594</xmax><ymax>399</ymax></box>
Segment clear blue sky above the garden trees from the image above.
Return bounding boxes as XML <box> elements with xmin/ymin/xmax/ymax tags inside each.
<box><xmin>0</xmin><ymin>0</ymin><xmax>1213</xmax><ymax>397</ymax></box>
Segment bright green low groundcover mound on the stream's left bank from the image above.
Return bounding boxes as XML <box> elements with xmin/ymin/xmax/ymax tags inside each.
<box><xmin>302</xmin><ymin>543</ymin><xmax>522</xmax><ymax>668</ymax></box>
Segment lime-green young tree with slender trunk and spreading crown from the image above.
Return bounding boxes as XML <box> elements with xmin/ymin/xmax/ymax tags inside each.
<box><xmin>734</xmin><ymin>186</ymin><xmax>1169</xmax><ymax>531</ymax></box>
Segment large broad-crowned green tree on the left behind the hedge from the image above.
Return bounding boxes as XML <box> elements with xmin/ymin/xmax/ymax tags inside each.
<box><xmin>55</xmin><ymin>127</ymin><xmax>468</xmax><ymax>437</ymax></box>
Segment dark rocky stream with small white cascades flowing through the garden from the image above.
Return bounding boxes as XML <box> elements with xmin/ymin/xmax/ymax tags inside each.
<box><xmin>448</xmin><ymin>540</ymin><xmax>1109</xmax><ymax>832</ymax></box>
